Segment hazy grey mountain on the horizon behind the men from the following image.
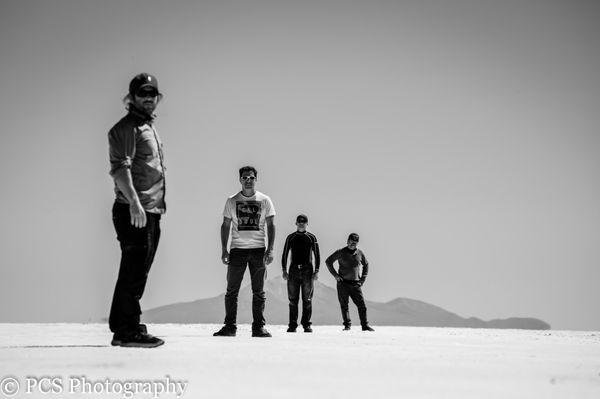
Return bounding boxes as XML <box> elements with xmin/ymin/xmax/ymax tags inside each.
<box><xmin>142</xmin><ymin>277</ymin><xmax>550</xmax><ymax>330</ymax></box>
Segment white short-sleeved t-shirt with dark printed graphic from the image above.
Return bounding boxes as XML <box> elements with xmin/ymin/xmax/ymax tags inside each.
<box><xmin>223</xmin><ymin>191</ymin><xmax>275</xmax><ymax>249</ymax></box>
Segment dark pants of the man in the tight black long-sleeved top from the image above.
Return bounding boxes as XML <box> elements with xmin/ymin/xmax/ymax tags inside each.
<box><xmin>288</xmin><ymin>265</ymin><xmax>314</xmax><ymax>328</ymax></box>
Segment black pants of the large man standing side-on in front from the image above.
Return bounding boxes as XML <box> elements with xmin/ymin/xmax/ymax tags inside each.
<box><xmin>108</xmin><ymin>203</ymin><xmax>160</xmax><ymax>335</ymax></box>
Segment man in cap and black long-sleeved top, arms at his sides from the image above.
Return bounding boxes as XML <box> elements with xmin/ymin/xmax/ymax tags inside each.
<box><xmin>281</xmin><ymin>215</ymin><xmax>321</xmax><ymax>332</ymax></box>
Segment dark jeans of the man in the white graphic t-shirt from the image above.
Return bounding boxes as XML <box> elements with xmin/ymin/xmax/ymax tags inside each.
<box><xmin>225</xmin><ymin>248</ymin><xmax>267</xmax><ymax>330</ymax></box>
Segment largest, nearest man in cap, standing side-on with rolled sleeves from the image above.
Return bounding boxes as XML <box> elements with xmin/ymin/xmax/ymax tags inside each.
<box><xmin>108</xmin><ymin>73</ymin><xmax>166</xmax><ymax>347</ymax></box>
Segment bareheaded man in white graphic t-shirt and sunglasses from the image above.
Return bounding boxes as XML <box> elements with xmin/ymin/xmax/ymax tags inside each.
<box><xmin>213</xmin><ymin>166</ymin><xmax>275</xmax><ymax>337</ymax></box>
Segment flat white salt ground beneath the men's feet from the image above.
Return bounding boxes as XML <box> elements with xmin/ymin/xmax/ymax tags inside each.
<box><xmin>0</xmin><ymin>324</ymin><xmax>600</xmax><ymax>399</ymax></box>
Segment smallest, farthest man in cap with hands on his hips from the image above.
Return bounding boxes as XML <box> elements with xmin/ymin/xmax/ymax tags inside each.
<box><xmin>325</xmin><ymin>233</ymin><xmax>374</xmax><ymax>331</ymax></box>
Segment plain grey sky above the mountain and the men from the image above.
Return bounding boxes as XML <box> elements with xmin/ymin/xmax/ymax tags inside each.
<box><xmin>0</xmin><ymin>0</ymin><xmax>600</xmax><ymax>330</ymax></box>
